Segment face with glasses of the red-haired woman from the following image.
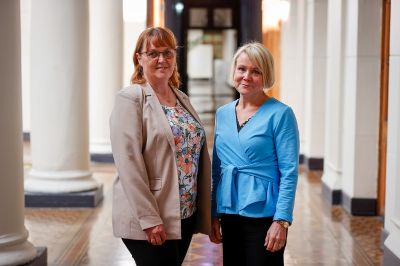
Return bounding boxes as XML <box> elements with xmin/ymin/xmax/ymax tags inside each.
<box><xmin>137</xmin><ymin>44</ymin><xmax>176</xmax><ymax>82</ymax></box>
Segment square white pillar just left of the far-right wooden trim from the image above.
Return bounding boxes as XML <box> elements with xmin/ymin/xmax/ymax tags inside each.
<box><xmin>342</xmin><ymin>0</ymin><xmax>381</xmax><ymax>204</ymax></box>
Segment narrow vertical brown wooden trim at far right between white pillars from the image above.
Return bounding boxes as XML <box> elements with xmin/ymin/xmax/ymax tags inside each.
<box><xmin>377</xmin><ymin>0</ymin><xmax>390</xmax><ymax>216</ymax></box>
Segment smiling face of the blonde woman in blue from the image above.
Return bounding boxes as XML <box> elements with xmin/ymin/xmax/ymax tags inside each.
<box><xmin>233</xmin><ymin>53</ymin><xmax>264</xmax><ymax>96</ymax></box>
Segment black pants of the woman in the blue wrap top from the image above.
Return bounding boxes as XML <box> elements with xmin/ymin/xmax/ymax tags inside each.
<box><xmin>221</xmin><ymin>214</ymin><xmax>286</xmax><ymax>266</ymax></box>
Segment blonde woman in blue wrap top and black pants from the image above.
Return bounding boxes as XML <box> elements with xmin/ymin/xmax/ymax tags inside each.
<box><xmin>210</xmin><ymin>42</ymin><xmax>299</xmax><ymax>266</ymax></box>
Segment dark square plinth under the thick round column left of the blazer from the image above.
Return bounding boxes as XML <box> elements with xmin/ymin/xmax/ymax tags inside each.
<box><xmin>25</xmin><ymin>184</ymin><xmax>103</xmax><ymax>208</ymax></box>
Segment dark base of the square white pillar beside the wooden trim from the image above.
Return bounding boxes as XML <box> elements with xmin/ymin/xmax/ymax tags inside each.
<box><xmin>342</xmin><ymin>192</ymin><xmax>377</xmax><ymax>216</ymax></box>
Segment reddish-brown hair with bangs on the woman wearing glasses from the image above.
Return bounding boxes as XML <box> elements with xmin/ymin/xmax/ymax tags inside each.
<box><xmin>131</xmin><ymin>27</ymin><xmax>181</xmax><ymax>88</ymax></box>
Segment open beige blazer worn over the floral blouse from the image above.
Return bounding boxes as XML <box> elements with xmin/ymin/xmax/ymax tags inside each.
<box><xmin>110</xmin><ymin>84</ymin><xmax>211</xmax><ymax>240</ymax></box>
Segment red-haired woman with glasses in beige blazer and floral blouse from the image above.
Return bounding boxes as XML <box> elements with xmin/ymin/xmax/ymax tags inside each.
<box><xmin>110</xmin><ymin>27</ymin><xmax>211</xmax><ymax>266</ymax></box>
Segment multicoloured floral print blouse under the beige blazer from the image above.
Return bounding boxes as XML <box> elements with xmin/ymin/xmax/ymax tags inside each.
<box><xmin>162</xmin><ymin>101</ymin><xmax>205</xmax><ymax>219</ymax></box>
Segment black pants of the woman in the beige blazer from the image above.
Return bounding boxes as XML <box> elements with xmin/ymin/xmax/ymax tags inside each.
<box><xmin>122</xmin><ymin>214</ymin><xmax>196</xmax><ymax>266</ymax></box>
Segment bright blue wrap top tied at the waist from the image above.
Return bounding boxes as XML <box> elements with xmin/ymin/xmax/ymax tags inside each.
<box><xmin>212</xmin><ymin>98</ymin><xmax>299</xmax><ymax>223</ymax></box>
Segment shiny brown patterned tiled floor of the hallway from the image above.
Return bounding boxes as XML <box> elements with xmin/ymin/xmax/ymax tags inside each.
<box><xmin>25</xmin><ymin>80</ymin><xmax>382</xmax><ymax>266</ymax></box>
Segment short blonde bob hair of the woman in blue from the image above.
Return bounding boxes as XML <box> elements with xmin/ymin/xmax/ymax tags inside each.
<box><xmin>230</xmin><ymin>42</ymin><xmax>275</xmax><ymax>89</ymax></box>
